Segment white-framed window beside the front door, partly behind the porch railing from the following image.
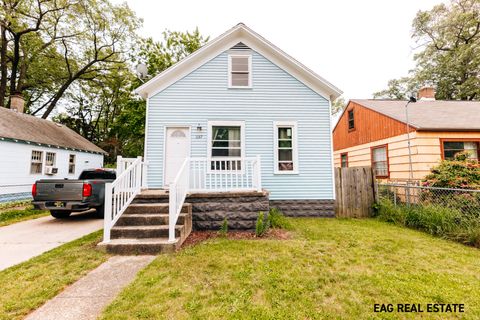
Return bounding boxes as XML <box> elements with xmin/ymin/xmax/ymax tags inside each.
<box><xmin>209</xmin><ymin>121</ymin><xmax>244</xmax><ymax>170</ymax></box>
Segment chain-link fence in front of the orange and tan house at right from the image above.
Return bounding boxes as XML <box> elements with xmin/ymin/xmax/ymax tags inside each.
<box><xmin>377</xmin><ymin>183</ymin><xmax>480</xmax><ymax>217</ymax></box>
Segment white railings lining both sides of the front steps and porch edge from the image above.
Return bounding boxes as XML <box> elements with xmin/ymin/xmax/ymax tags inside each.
<box><xmin>103</xmin><ymin>156</ymin><xmax>262</xmax><ymax>242</ymax></box>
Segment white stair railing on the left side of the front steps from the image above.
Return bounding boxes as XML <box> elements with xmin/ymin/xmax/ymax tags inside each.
<box><xmin>103</xmin><ymin>157</ymin><xmax>144</xmax><ymax>243</ymax></box>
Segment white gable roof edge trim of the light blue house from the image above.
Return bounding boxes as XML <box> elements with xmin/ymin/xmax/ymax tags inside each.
<box><xmin>135</xmin><ymin>23</ymin><xmax>343</xmax><ymax>101</ymax></box>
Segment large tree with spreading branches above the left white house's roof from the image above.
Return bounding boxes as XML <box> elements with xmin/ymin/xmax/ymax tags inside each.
<box><xmin>0</xmin><ymin>0</ymin><xmax>140</xmax><ymax>118</ymax></box>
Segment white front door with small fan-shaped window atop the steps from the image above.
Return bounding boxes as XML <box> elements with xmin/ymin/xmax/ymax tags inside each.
<box><xmin>164</xmin><ymin>127</ymin><xmax>190</xmax><ymax>187</ymax></box>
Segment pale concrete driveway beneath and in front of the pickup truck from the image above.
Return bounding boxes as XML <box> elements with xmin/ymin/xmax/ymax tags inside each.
<box><xmin>0</xmin><ymin>213</ymin><xmax>103</xmax><ymax>270</ymax></box>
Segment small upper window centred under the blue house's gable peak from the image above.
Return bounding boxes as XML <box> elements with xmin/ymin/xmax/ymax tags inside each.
<box><xmin>228</xmin><ymin>53</ymin><xmax>252</xmax><ymax>88</ymax></box>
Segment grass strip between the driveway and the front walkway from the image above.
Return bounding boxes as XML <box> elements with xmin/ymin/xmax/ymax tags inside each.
<box><xmin>0</xmin><ymin>231</ymin><xmax>108</xmax><ymax>320</ymax></box>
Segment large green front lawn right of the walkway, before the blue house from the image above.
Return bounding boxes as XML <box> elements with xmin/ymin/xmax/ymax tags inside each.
<box><xmin>102</xmin><ymin>219</ymin><xmax>480</xmax><ymax>319</ymax></box>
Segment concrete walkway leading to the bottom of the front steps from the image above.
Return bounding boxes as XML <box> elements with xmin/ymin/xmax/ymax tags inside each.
<box><xmin>26</xmin><ymin>256</ymin><xmax>155</xmax><ymax>320</ymax></box>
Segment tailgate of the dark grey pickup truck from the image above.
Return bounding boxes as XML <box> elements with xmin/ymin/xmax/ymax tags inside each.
<box><xmin>35</xmin><ymin>180</ymin><xmax>83</xmax><ymax>201</ymax></box>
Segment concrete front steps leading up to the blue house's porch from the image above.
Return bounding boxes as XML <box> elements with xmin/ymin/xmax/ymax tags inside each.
<box><xmin>105</xmin><ymin>203</ymin><xmax>192</xmax><ymax>255</ymax></box>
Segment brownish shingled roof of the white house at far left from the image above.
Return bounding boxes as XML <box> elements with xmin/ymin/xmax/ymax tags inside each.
<box><xmin>0</xmin><ymin>107</ymin><xmax>106</xmax><ymax>154</ymax></box>
